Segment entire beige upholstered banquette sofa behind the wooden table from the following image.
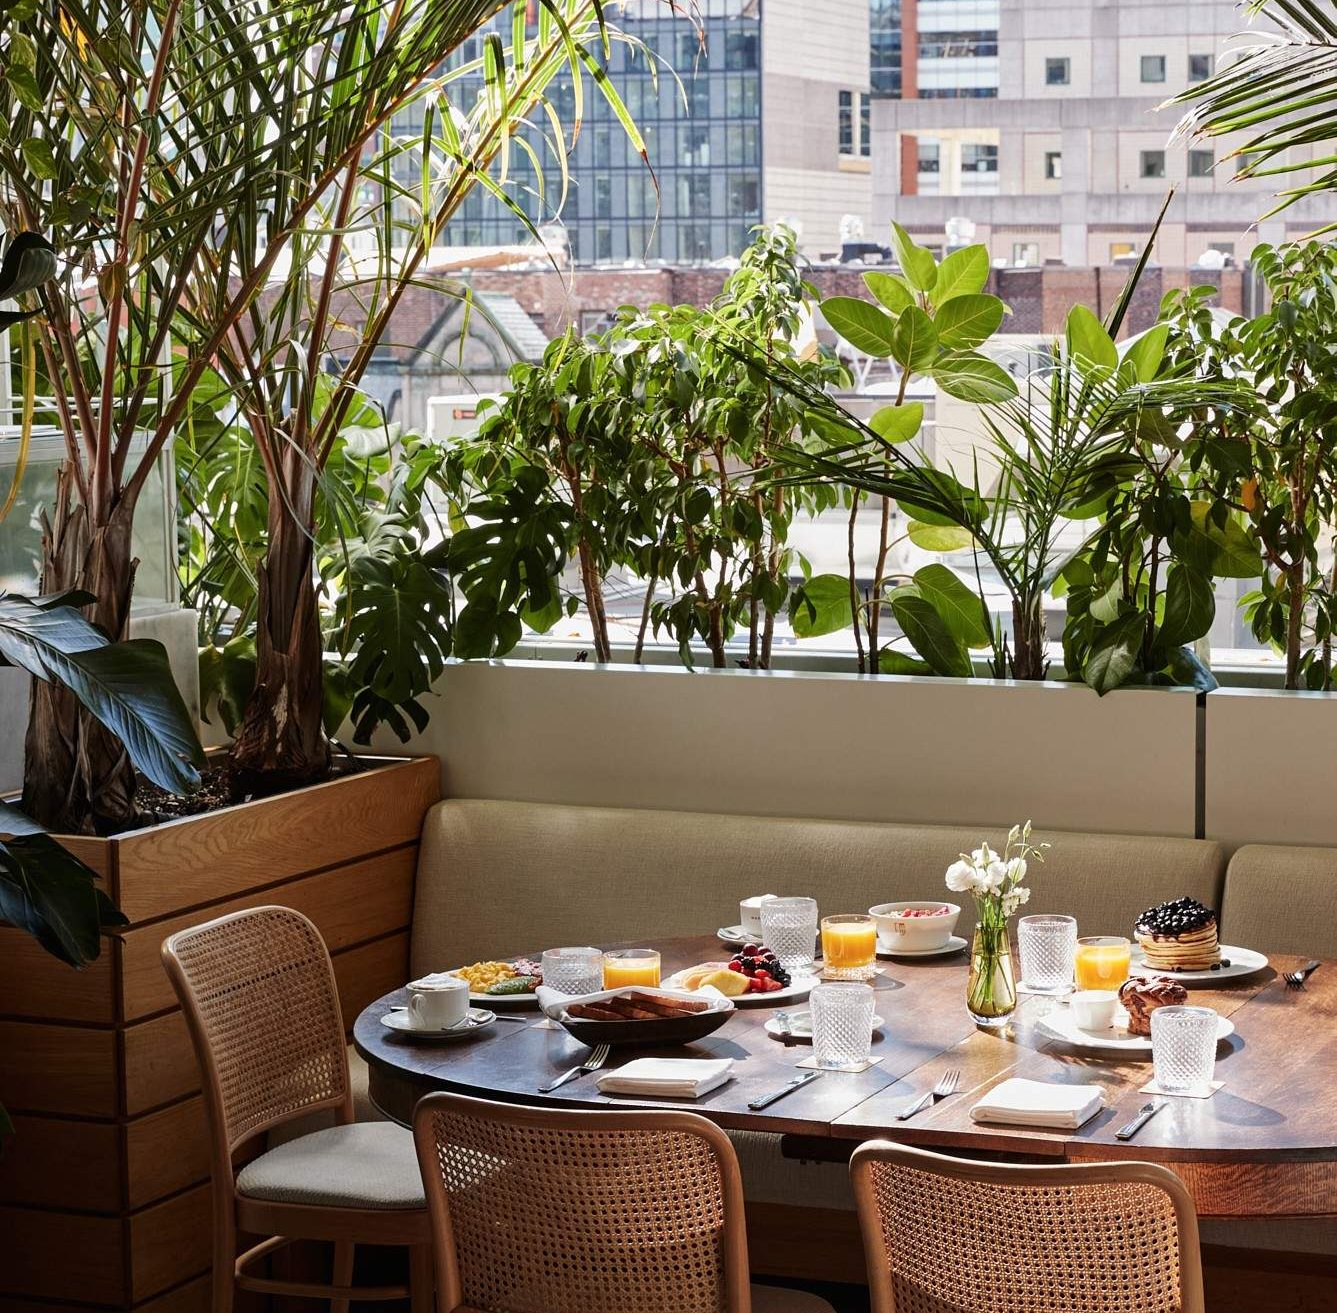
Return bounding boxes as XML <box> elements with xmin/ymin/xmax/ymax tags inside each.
<box><xmin>360</xmin><ymin>800</ymin><xmax>1337</xmax><ymax>1267</ymax></box>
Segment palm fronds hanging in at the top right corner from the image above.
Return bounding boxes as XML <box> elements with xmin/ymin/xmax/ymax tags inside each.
<box><xmin>1166</xmin><ymin>0</ymin><xmax>1337</xmax><ymax>228</ymax></box>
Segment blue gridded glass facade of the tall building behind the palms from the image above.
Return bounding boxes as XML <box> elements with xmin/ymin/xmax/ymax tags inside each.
<box><xmin>433</xmin><ymin>0</ymin><xmax>762</xmax><ymax>265</ymax></box>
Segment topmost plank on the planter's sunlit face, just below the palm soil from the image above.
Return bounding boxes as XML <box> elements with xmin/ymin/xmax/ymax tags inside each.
<box><xmin>116</xmin><ymin>758</ymin><xmax>441</xmax><ymax>921</ymax></box>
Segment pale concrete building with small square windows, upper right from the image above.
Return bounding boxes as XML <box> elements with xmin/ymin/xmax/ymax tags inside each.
<box><xmin>872</xmin><ymin>0</ymin><xmax>1322</xmax><ymax>266</ymax></box>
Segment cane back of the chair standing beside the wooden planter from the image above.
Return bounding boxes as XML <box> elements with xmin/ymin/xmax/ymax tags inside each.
<box><xmin>163</xmin><ymin>907</ymin><xmax>353</xmax><ymax>1160</ymax></box>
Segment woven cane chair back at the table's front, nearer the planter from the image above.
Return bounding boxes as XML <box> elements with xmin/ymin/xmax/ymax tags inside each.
<box><xmin>413</xmin><ymin>1094</ymin><xmax>751</xmax><ymax>1313</ymax></box>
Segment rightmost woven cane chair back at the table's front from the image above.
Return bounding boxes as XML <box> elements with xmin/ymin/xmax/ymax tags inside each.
<box><xmin>850</xmin><ymin>1141</ymin><xmax>1203</xmax><ymax>1313</ymax></box>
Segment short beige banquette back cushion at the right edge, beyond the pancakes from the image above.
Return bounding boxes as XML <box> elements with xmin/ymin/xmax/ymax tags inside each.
<box><xmin>1221</xmin><ymin>844</ymin><xmax>1337</xmax><ymax>957</ymax></box>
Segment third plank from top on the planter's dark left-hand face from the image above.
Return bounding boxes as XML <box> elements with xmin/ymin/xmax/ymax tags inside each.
<box><xmin>0</xmin><ymin>1022</ymin><xmax>119</xmax><ymax>1116</ymax></box>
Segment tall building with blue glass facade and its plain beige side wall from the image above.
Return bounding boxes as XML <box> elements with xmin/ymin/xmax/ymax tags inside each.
<box><xmin>438</xmin><ymin>0</ymin><xmax>872</xmax><ymax>265</ymax></box>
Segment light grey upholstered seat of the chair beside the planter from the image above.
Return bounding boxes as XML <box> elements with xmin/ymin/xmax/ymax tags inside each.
<box><xmin>237</xmin><ymin>1122</ymin><xmax>427</xmax><ymax>1209</ymax></box>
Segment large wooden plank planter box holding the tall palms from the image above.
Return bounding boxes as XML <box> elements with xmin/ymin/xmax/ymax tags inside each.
<box><xmin>0</xmin><ymin>757</ymin><xmax>440</xmax><ymax>1313</ymax></box>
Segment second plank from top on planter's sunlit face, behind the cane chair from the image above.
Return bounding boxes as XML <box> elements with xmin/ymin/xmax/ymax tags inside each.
<box><xmin>122</xmin><ymin>842</ymin><xmax>417</xmax><ymax>1022</ymax></box>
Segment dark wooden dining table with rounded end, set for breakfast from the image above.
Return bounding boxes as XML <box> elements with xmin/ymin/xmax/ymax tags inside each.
<box><xmin>354</xmin><ymin>937</ymin><xmax>1337</xmax><ymax>1217</ymax></box>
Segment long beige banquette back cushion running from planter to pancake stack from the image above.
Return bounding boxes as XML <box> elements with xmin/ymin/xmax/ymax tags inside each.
<box><xmin>412</xmin><ymin>800</ymin><xmax>1225</xmax><ymax>975</ymax></box>
